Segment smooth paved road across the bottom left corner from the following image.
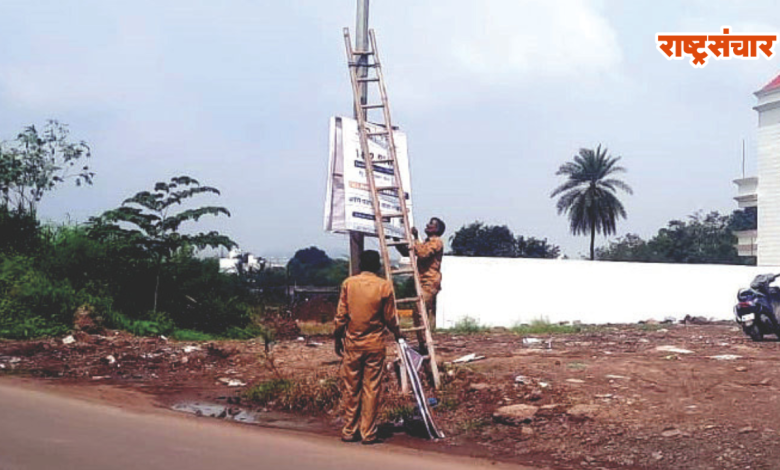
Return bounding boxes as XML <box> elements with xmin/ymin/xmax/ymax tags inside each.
<box><xmin>0</xmin><ymin>383</ymin><xmax>532</xmax><ymax>470</ymax></box>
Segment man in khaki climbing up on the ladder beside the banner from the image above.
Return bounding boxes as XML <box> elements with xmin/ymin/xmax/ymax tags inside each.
<box><xmin>412</xmin><ymin>217</ymin><xmax>446</xmax><ymax>331</ymax></box>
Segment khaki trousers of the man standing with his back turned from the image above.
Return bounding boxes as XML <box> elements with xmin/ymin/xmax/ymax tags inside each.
<box><xmin>341</xmin><ymin>348</ymin><xmax>385</xmax><ymax>441</ymax></box>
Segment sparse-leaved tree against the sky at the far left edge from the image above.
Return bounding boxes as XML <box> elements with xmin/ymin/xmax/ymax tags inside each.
<box><xmin>0</xmin><ymin>121</ymin><xmax>95</xmax><ymax>213</ymax></box>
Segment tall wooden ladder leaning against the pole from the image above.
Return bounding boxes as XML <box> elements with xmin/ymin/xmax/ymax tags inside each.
<box><xmin>344</xmin><ymin>28</ymin><xmax>441</xmax><ymax>392</ymax></box>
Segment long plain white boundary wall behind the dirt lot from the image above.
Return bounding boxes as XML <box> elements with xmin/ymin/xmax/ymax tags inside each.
<box><xmin>436</xmin><ymin>256</ymin><xmax>780</xmax><ymax>328</ymax></box>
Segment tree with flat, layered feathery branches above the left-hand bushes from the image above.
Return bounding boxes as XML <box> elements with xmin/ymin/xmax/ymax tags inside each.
<box><xmin>90</xmin><ymin>176</ymin><xmax>236</xmax><ymax>311</ymax></box>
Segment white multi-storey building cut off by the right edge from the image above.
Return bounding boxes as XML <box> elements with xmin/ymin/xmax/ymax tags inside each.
<box><xmin>734</xmin><ymin>75</ymin><xmax>780</xmax><ymax>266</ymax></box>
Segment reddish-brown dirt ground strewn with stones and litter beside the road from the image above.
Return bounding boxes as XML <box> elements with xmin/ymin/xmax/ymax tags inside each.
<box><xmin>0</xmin><ymin>323</ymin><xmax>780</xmax><ymax>469</ymax></box>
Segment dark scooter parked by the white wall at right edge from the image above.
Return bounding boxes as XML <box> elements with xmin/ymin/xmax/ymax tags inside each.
<box><xmin>734</xmin><ymin>274</ymin><xmax>780</xmax><ymax>341</ymax></box>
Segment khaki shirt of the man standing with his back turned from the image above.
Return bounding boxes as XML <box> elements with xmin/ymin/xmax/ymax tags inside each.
<box><xmin>335</xmin><ymin>271</ymin><xmax>401</xmax><ymax>351</ymax></box>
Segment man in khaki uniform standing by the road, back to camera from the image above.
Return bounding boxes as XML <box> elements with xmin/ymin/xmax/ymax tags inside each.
<box><xmin>335</xmin><ymin>250</ymin><xmax>402</xmax><ymax>444</ymax></box>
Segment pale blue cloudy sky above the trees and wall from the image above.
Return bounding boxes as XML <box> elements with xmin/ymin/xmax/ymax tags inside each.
<box><xmin>0</xmin><ymin>0</ymin><xmax>780</xmax><ymax>257</ymax></box>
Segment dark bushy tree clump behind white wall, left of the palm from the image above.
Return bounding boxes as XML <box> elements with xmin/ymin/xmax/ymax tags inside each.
<box><xmin>450</xmin><ymin>221</ymin><xmax>561</xmax><ymax>258</ymax></box>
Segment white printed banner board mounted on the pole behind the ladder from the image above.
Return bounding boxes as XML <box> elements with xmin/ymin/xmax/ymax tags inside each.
<box><xmin>324</xmin><ymin>116</ymin><xmax>412</xmax><ymax>237</ymax></box>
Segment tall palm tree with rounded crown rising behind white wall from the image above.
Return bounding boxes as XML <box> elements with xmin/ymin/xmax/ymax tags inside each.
<box><xmin>550</xmin><ymin>145</ymin><xmax>634</xmax><ymax>259</ymax></box>
